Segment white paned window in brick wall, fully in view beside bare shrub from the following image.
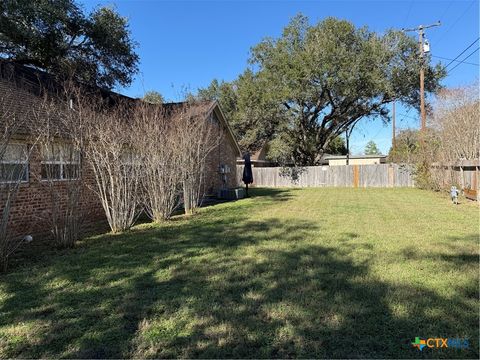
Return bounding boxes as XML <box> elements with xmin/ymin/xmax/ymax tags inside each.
<box><xmin>42</xmin><ymin>144</ymin><xmax>80</xmax><ymax>180</ymax></box>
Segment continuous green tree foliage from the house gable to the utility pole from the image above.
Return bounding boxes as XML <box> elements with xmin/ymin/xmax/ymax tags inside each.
<box><xmin>200</xmin><ymin>15</ymin><xmax>445</xmax><ymax>165</ymax></box>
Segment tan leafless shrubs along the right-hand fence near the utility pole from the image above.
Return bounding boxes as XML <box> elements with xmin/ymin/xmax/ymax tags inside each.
<box><xmin>389</xmin><ymin>84</ymin><xmax>480</xmax><ymax>190</ymax></box>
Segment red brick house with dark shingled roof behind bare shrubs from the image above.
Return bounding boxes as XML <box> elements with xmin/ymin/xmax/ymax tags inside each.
<box><xmin>0</xmin><ymin>61</ymin><xmax>241</xmax><ymax>240</ymax></box>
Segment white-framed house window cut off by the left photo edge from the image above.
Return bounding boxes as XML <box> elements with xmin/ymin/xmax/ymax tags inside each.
<box><xmin>0</xmin><ymin>144</ymin><xmax>28</xmax><ymax>183</ymax></box>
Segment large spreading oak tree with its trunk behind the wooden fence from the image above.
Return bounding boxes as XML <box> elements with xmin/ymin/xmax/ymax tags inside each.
<box><xmin>251</xmin><ymin>15</ymin><xmax>444</xmax><ymax>165</ymax></box>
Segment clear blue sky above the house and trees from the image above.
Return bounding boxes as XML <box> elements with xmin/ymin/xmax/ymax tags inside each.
<box><xmin>81</xmin><ymin>0</ymin><xmax>479</xmax><ymax>153</ymax></box>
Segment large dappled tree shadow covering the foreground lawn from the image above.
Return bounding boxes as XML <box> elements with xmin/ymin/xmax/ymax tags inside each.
<box><xmin>0</xmin><ymin>211</ymin><xmax>478</xmax><ymax>358</ymax></box>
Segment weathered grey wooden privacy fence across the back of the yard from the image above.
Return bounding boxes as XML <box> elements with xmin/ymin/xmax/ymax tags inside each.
<box><xmin>237</xmin><ymin>164</ymin><xmax>414</xmax><ymax>187</ymax></box>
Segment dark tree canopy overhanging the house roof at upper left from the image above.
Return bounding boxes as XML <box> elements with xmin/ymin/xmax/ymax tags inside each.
<box><xmin>0</xmin><ymin>0</ymin><xmax>138</xmax><ymax>89</ymax></box>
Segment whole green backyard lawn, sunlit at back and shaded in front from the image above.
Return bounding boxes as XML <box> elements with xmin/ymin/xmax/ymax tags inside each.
<box><xmin>0</xmin><ymin>188</ymin><xmax>479</xmax><ymax>358</ymax></box>
